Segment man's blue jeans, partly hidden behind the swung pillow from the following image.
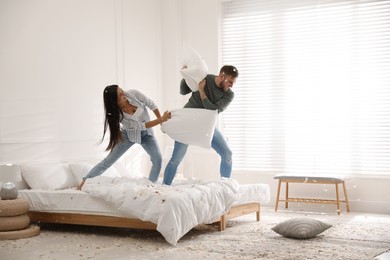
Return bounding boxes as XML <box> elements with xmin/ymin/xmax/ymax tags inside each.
<box><xmin>163</xmin><ymin>129</ymin><xmax>232</xmax><ymax>185</ymax></box>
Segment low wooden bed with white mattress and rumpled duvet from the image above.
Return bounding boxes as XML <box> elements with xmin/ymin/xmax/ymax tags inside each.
<box><xmin>2</xmin><ymin>162</ymin><xmax>270</xmax><ymax>245</ymax></box>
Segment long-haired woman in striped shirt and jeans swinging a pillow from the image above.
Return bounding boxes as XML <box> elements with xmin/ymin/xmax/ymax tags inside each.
<box><xmin>77</xmin><ymin>85</ymin><xmax>171</xmax><ymax>190</ymax></box>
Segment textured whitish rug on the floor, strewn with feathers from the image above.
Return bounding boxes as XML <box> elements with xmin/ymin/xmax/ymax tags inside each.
<box><xmin>0</xmin><ymin>208</ymin><xmax>390</xmax><ymax>260</ymax></box>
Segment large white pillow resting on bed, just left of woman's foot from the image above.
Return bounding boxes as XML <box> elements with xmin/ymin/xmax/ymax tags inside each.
<box><xmin>20</xmin><ymin>163</ymin><xmax>77</xmax><ymax>190</ymax></box>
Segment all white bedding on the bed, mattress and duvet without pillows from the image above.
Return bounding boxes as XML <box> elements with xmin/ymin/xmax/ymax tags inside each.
<box><xmin>19</xmin><ymin>176</ymin><xmax>270</xmax><ymax>245</ymax></box>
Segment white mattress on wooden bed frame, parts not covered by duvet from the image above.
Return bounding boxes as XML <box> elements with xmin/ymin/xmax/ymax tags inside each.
<box><xmin>19</xmin><ymin>184</ymin><xmax>270</xmax><ymax>217</ymax></box>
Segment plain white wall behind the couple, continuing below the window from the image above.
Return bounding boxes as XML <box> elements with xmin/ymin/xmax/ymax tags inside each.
<box><xmin>0</xmin><ymin>0</ymin><xmax>390</xmax><ymax>214</ymax></box>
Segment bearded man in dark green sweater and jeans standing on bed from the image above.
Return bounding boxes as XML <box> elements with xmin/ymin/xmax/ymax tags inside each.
<box><xmin>163</xmin><ymin>65</ymin><xmax>238</xmax><ymax>185</ymax></box>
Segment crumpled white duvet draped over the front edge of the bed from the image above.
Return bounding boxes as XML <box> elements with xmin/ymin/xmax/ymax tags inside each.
<box><xmin>83</xmin><ymin>176</ymin><xmax>239</xmax><ymax>245</ymax></box>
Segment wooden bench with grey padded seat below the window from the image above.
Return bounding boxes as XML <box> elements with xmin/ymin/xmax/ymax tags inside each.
<box><xmin>274</xmin><ymin>174</ymin><xmax>349</xmax><ymax>215</ymax></box>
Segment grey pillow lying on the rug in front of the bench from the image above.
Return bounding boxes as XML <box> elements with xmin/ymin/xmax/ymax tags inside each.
<box><xmin>272</xmin><ymin>218</ymin><xmax>332</xmax><ymax>239</ymax></box>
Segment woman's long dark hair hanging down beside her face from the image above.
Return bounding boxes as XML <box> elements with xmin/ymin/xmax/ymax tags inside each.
<box><xmin>100</xmin><ymin>85</ymin><xmax>123</xmax><ymax>151</ymax></box>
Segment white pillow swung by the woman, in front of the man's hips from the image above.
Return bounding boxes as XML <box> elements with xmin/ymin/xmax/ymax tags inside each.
<box><xmin>161</xmin><ymin>108</ymin><xmax>218</xmax><ymax>149</ymax></box>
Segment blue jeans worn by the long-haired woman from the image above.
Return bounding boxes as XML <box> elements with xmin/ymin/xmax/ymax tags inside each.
<box><xmin>83</xmin><ymin>130</ymin><xmax>162</xmax><ymax>182</ymax></box>
